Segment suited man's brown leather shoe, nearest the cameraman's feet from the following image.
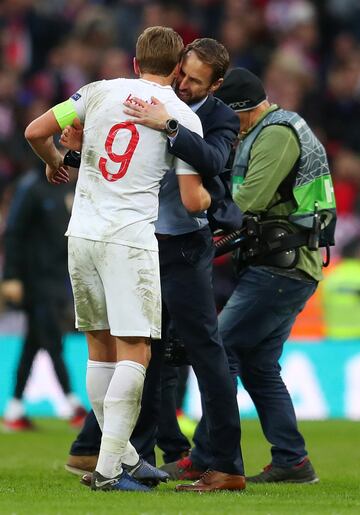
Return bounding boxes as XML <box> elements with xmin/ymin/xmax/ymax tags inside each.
<box><xmin>175</xmin><ymin>470</ymin><xmax>246</xmax><ymax>492</ymax></box>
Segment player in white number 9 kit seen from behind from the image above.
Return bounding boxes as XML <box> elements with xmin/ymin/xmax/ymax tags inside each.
<box><xmin>25</xmin><ymin>27</ymin><xmax>210</xmax><ymax>491</ymax></box>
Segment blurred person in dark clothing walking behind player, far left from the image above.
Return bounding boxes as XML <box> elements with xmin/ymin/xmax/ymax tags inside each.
<box><xmin>2</xmin><ymin>171</ymin><xmax>86</xmax><ymax>431</ymax></box>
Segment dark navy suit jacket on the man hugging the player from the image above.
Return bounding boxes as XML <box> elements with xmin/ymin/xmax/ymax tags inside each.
<box><xmin>169</xmin><ymin>95</ymin><xmax>242</xmax><ymax>231</ymax></box>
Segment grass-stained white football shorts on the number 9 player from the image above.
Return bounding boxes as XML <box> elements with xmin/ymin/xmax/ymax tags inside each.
<box><xmin>68</xmin><ymin>236</ymin><xmax>161</xmax><ymax>339</ymax></box>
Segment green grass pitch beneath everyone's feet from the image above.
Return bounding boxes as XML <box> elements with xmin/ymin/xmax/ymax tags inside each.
<box><xmin>0</xmin><ymin>419</ymin><xmax>360</xmax><ymax>515</ymax></box>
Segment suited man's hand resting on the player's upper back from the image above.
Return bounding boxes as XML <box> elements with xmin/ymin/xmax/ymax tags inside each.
<box><xmin>124</xmin><ymin>97</ymin><xmax>170</xmax><ymax>130</ymax></box>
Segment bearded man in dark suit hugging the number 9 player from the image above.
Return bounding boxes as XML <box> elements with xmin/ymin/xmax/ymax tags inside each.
<box><xmin>68</xmin><ymin>38</ymin><xmax>245</xmax><ymax>491</ymax></box>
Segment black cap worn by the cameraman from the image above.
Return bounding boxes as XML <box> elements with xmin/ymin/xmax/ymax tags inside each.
<box><xmin>214</xmin><ymin>68</ymin><xmax>266</xmax><ymax>111</ymax></box>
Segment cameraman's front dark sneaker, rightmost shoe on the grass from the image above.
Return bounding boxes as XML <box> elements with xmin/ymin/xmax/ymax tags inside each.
<box><xmin>246</xmin><ymin>458</ymin><xmax>319</xmax><ymax>483</ymax></box>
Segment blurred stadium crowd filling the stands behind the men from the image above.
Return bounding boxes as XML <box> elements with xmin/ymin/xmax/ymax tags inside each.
<box><xmin>0</xmin><ymin>0</ymin><xmax>360</xmax><ymax>322</ymax></box>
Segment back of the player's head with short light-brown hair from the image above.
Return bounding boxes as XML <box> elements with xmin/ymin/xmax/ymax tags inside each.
<box><xmin>136</xmin><ymin>27</ymin><xmax>184</xmax><ymax>77</ymax></box>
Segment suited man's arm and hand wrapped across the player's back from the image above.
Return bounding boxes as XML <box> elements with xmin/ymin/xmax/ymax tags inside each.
<box><xmin>124</xmin><ymin>97</ymin><xmax>240</xmax><ymax>178</ymax></box>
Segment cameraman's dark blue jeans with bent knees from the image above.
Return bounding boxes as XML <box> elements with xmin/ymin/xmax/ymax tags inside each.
<box><xmin>191</xmin><ymin>267</ymin><xmax>317</xmax><ymax>469</ymax></box>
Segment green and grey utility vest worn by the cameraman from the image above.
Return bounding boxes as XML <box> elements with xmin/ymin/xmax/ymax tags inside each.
<box><xmin>232</xmin><ymin>109</ymin><xmax>336</xmax><ymax>246</ymax></box>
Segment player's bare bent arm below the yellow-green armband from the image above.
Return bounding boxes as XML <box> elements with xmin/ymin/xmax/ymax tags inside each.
<box><xmin>25</xmin><ymin>109</ymin><xmax>69</xmax><ymax>184</ymax></box>
